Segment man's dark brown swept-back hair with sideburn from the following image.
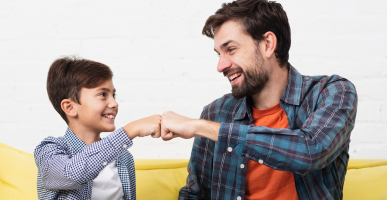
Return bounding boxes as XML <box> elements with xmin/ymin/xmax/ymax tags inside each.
<box><xmin>202</xmin><ymin>0</ymin><xmax>291</xmax><ymax>67</ymax></box>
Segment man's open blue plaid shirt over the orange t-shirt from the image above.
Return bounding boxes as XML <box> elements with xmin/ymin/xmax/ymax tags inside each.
<box><xmin>179</xmin><ymin>66</ymin><xmax>357</xmax><ymax>200</ymax></box>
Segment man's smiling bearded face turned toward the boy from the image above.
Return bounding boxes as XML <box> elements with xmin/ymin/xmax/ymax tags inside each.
<box><xmin>214</xmin><ymin>21</ymin><xmax>271</xmax><ymax>98</ymax></box>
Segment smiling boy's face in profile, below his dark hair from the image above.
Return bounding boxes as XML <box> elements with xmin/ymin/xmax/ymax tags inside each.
<box><xmin>76</xmin><ymin>80</ymin><xmax>118</xmax><ymax>133</ymax></box>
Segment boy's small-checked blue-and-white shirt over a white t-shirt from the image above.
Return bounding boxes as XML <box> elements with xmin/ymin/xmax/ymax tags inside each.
<box><xmin>34</xmin><ymin>128</ymin><xmax>136</xmax><ymax>200</ymax></box>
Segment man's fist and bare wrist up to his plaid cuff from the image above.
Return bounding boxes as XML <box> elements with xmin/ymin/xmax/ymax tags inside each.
<box><xmin>161</xmin><ymin>111</ymin><xmax>220</xmax><ymax>141</ymax></box>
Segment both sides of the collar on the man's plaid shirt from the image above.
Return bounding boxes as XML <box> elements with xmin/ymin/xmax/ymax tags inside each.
<box><xmin>234</xmin><ymin>65</ymin><xmax>302</xmax><ymax>120</ymax></box>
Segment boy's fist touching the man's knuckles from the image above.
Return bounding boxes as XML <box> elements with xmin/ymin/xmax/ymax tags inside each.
<box><xmin>124</xmin><ymin>115</ymin><xmax>161</xmax><ymax>140</ymax></box>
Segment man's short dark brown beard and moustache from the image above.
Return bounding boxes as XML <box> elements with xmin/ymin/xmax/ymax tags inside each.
<box><xmin>225</xmin><ymin>53</ymin><xmax>269</xmax><ymax>99</ymax></box>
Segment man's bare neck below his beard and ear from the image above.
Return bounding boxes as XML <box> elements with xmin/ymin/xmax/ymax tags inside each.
<box><xmin>252</xmin><ymin>65</ymin><xmax>289</xmax><ymax>110</ymax></box>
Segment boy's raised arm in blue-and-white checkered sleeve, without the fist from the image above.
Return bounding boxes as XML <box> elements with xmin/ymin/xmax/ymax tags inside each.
<box><xmin>34</xmin><ymin>128</ymin><xmax>133</xmax><ymax>190</ymax></box>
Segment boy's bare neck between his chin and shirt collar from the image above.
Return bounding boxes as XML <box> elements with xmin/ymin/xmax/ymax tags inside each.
<box><xmin>69</xmin><ymin>123</ymin><xmax>101</xmax><ymax>146</ymax></box>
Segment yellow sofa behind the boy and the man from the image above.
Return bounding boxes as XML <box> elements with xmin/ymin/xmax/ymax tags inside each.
<box><xmin>0</xmin><ymin>143</ymin><xmax>387</xmax><ymax>200</ymax></box>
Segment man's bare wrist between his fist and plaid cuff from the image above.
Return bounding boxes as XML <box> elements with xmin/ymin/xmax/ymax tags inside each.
<box><xmin>193</xmin><ymin>119</ymin><xmax>220</xmax><ymax>142</ymax></box>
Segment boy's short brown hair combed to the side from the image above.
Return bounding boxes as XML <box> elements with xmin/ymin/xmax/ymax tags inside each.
<box><xmin>47</xmin><ymin>56</ymin><xmax>113</xmax><ymax>124</ymax></box>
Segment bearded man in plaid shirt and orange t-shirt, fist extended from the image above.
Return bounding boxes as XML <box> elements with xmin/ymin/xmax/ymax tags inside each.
<box><xmin>161</xmin><ymin>0</ymin><xmax>357</xmax><ymax>200</ymax></box>
